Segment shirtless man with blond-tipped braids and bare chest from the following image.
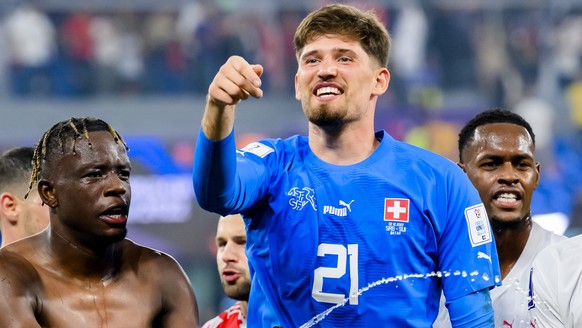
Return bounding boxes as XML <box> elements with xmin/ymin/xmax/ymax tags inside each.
<box><xmin>0</xmin><ymin>118</ymin><xmax>198</xmax><ymax>328</ymax></box>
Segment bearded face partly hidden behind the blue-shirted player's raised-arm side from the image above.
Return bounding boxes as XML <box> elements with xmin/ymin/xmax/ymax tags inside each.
<box><xmin>216</xmin><ymin>214</ymin><xmax>251</xmax><ymax>301</ymax></box>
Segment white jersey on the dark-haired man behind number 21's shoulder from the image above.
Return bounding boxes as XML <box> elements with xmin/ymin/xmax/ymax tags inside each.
<box><xmin>433</xmin><ymin>222</ymin><xmax>568</xmax><ymax>328</ymax></box>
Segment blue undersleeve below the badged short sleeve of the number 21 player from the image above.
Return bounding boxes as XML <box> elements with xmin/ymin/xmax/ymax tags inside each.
<box><xmin>446</xmin><ymin>288</ymin><xmax>495</xmax><ymax>328</ymax></box>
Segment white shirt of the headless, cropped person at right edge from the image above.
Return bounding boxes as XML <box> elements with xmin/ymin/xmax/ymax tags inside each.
<box><xmin>530</xmin><ymin>235</ymin><xmax>582</xmax><ymax>328</ymax></box>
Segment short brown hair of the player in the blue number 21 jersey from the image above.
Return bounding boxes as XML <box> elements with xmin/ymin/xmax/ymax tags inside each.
<box><xmin>294</xmin><ymin>4</ymin><xmax>390</xmax><ymax>67</ymax></box>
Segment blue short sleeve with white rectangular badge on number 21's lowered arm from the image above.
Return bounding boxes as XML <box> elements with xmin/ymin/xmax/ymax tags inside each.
<box><xmin>435</xmin><ymin>163</ymin><xmax>501</xmax><ymax>299</ymax></box>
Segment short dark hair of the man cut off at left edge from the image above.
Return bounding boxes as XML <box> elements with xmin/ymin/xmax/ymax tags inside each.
<box><xmin>0</xmin><ymin>147</ymin><xmax>34</xmax><ymax>197</ymax></box>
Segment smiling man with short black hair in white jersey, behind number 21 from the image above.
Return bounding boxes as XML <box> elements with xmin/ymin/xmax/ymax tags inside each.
<box><xmin>434</xmin><ymin>109</ymin><xmax>565</xmax><ymax>328</ymax></box>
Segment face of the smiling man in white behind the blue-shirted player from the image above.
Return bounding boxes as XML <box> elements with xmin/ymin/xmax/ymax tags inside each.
<box><xmin>460</xmin><ymin>123</ymin><xmax>540</xmax><ymax>223</ymax></box>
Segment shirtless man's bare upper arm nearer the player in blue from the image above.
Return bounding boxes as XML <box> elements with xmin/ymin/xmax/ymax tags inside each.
<box><xmin>156</xmin><ymin>254</ymin><xmax>200</xmax><ymax>328</ymax></box>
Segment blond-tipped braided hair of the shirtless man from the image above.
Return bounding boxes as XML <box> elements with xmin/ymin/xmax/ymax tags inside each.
<box><xmin>24</xmin><ymin>117</ymin><xmax>129</xmax><ymax>199</ymax></box>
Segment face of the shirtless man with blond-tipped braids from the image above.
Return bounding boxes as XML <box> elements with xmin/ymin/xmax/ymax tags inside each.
<box><xmin>39</xmin><ymin>131</ymin><xmax>131</xmax><ymax>245</ymax></box>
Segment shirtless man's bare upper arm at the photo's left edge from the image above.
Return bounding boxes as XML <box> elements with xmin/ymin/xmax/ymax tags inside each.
<box><xmin>0</xmin><ymin>252</ymin><xmax>40</xmax><ymax>328</ymax></box>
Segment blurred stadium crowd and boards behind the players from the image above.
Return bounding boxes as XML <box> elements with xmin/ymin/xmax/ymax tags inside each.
<box><xmin>0</xmin><ymin>0</ymin><xmax>582</xmax><ymax>321</ymax></box>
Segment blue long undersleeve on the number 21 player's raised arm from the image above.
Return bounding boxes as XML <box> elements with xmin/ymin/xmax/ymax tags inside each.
<box><xmin>192</xmin><ymin>129</ymin><xmax>236</xmax><ymax>215</ymax></box>
